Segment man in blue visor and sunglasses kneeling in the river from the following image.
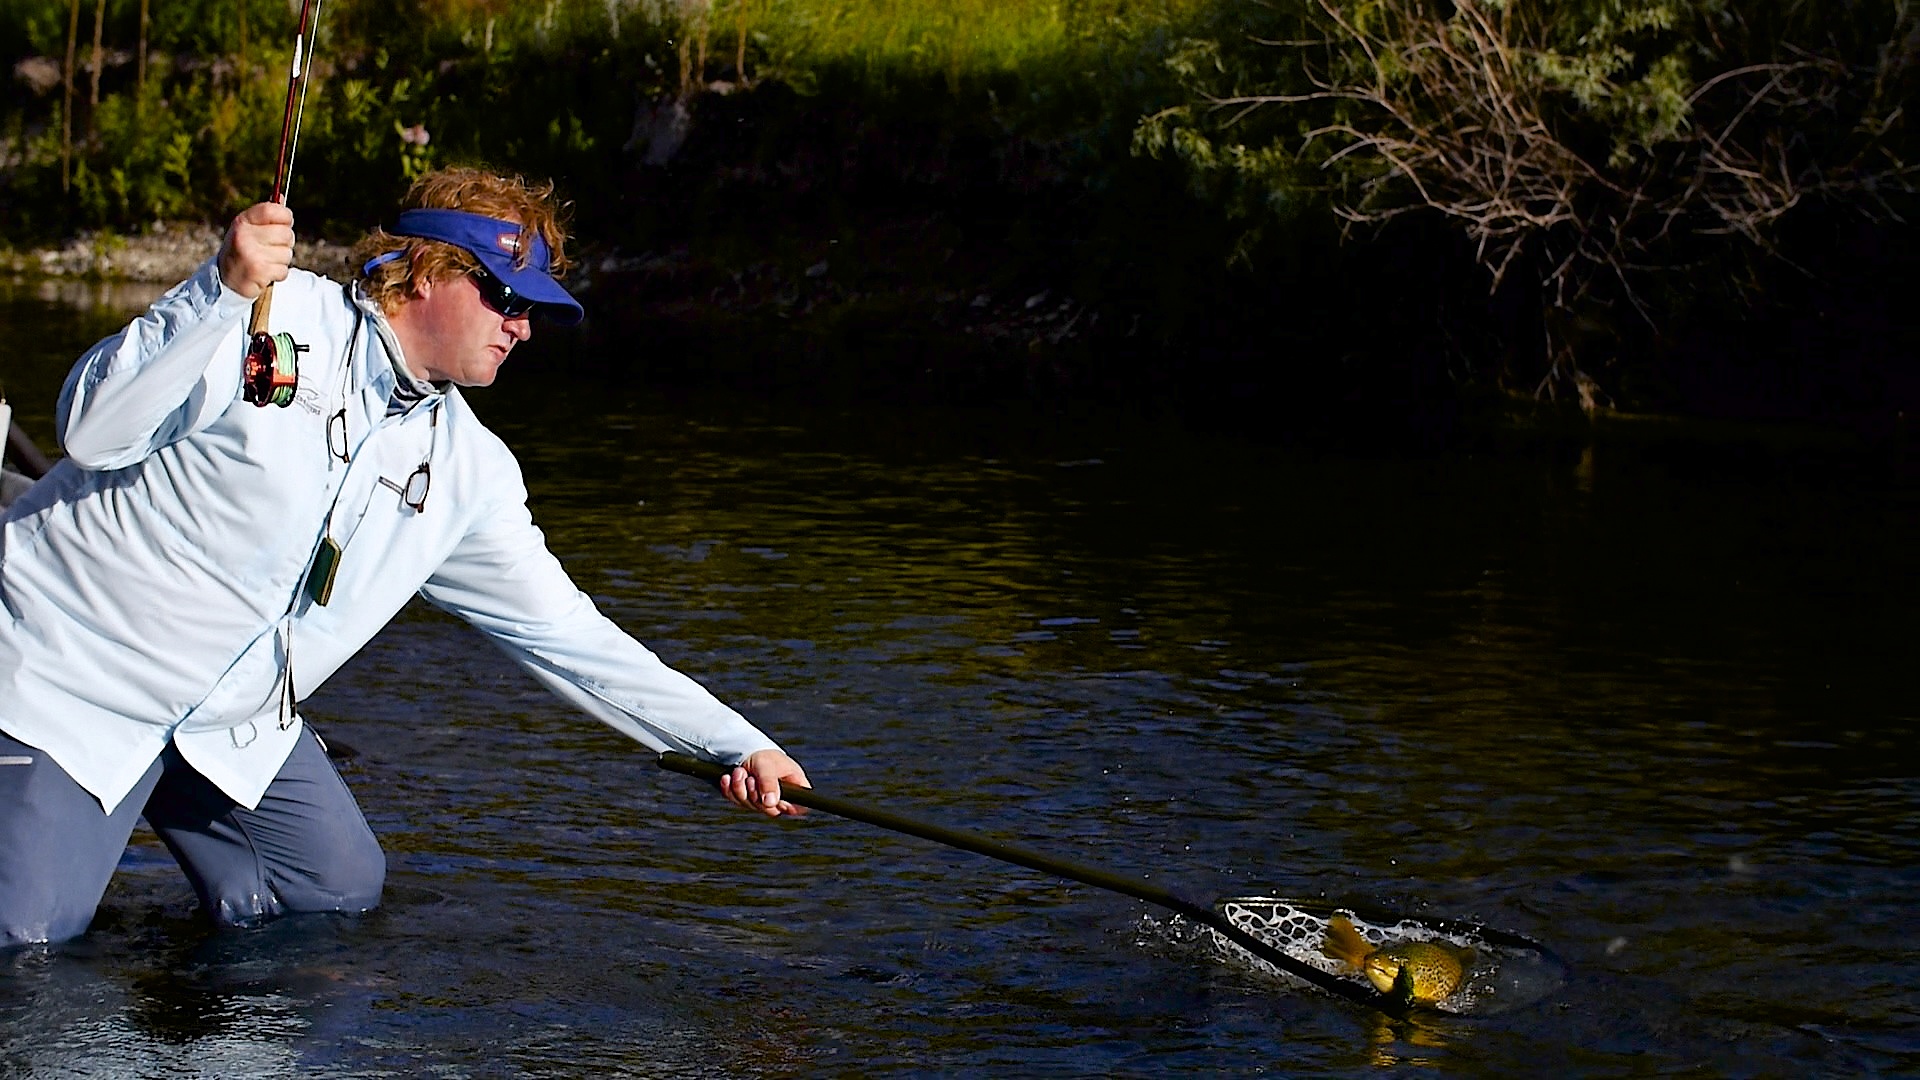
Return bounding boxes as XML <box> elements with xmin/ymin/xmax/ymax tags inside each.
<box><xmin>0</xmin><ymin>161</ymin><xmax>806</xmax><ymax>944</ymax></box>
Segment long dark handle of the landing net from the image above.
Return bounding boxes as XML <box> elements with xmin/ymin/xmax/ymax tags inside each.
<box><xmin>660</xmin><ymin>749</ymin><xmax>1407</xmax><ymax>1017</ymax></box>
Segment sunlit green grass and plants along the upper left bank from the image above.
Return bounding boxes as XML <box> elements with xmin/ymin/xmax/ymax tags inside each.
<box><xmin>0</xmin><ymin>0</ymin><xmax>1196</xmax><ymax>228</ymax></box>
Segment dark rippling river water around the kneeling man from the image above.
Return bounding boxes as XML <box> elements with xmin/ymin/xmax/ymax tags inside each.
<box><xmin>0</xmin><ymin>278</ymin><xmax>1920</xmax><ymax>1076</ymax></box>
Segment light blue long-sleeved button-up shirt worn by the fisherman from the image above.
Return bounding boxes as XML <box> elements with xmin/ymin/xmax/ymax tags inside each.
<box><xmin>0</xmin><ymin>261</ymin><xmax>774</xmax><ymax>813</ymax></box>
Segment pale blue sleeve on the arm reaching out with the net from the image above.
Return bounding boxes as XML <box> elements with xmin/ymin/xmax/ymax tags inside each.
<box><xmin>420</xmin><ymin>455</ymin><xmax>778</xmax><ymax>765</ymax></box>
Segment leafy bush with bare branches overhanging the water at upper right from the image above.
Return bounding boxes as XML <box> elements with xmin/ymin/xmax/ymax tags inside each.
<box><xmin>1139</xmin><ymin>0</ymin><xmax>1920</xmax><ymax>407</ymax></box>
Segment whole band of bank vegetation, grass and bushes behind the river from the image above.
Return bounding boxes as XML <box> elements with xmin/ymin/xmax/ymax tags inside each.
<box><xmin>0</xmin><ymin>0</ymin><xmax>1920</xmax><ymax>424</ymax></box>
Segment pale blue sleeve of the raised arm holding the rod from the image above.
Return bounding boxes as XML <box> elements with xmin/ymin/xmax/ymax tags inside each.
<box><xmin>58</xmin><ymin>259</ymin><xmax>252</xmax><ymax>469</ymax></box>
